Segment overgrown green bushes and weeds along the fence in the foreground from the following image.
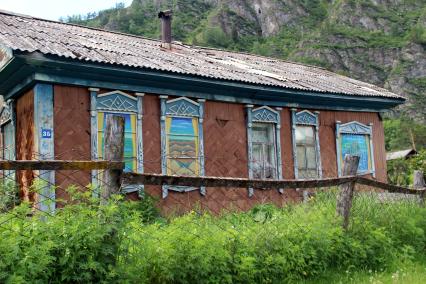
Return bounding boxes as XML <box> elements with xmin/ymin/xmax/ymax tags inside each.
<box><xmin>0</xmin><ymin>191</ymin><xmax>426</xmax><ymax>283</ymax></box>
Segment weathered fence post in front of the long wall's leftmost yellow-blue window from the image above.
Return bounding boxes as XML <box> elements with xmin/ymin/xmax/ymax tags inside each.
<box><xmin>101</xmin><ymin>115</ymin><xmax>124</xmax><ymax>202</ymax></box>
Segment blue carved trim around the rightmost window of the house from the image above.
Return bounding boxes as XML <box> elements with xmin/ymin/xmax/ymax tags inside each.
<box><xmin>336</xmin><ymin>121</ymin><xmax>376</xmax><ymax>177</ymax></box>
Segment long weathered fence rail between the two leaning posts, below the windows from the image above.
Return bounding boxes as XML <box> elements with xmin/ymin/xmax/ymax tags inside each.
<box><xmin>122</xmin><ymin>173</ymin><xmax>357</xmax><ymax>189</ymax></box>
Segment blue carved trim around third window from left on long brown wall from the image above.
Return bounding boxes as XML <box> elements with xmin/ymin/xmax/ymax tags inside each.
<box><xmin>246</xmin><ymin>105</ymin><xmax>284</xmax><ymax>197</ymax></box>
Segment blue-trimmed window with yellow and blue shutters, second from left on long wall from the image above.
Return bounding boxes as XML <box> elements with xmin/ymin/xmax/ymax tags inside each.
<box><xmin>160</xmin><ymin>96</ymin><xmax>205</xmax><ymax>198</ymax></box>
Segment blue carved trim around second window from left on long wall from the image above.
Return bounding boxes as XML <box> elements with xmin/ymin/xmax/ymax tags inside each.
<box><xmin>160</xmin><ymin>96</ymin><xmax>206</xmax><ymax>198</ymax></box>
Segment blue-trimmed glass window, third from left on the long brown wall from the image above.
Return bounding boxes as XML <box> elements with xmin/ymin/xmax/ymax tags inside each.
<box><xmin>246</xmin><ymin>105</ymin><xmax>283</xmax><ymax>196</ymax></box>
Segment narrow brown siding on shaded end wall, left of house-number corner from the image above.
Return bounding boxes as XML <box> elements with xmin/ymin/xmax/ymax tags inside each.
<box><xmin>16</xmin><ymin>90</ymin><xmax>36</xmax><ymax>202</ymax></box>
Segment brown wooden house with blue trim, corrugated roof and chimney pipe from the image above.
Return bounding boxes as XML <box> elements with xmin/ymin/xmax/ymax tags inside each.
<box><xmin>0</xmin><ymin>11</ymin><xmax>404</xmax><ymax>211</ymax></box>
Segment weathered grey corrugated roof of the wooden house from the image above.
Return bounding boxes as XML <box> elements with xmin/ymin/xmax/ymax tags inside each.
<box><xmin>0</xmin><ymin>10</ymin><xmax>402</xmax><ymax>99</ymax></box>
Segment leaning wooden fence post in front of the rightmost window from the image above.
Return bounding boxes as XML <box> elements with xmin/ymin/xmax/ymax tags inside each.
<box><xmin>336</xmin><ymin>155</ymin><xmax>359</xmax><ymax>230</ymax></box>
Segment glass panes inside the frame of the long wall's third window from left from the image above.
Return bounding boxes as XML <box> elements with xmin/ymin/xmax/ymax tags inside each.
<box><xmin>252</xmin><ymin>123</ymin><xmax>277</xmax><ymax>179</ymax></box>
